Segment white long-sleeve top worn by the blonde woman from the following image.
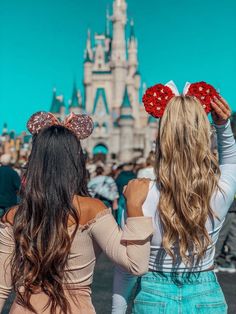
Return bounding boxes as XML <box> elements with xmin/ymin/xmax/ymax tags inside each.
<box><xmin>112</xmin><ymin>121</ymin><xmax>236</xmax><ymax>314</ymax></box>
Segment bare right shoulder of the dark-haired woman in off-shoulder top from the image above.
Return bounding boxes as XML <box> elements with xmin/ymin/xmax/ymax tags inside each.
<box><xmin>73</xmin><ymin>196</ymin><xmax>108</xmax><ymax>225</ymax></box>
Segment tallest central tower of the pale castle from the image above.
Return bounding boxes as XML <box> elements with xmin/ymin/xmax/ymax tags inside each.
<box><xmin>111</xmin><ymin>0</ymin><xmax>127</xmax><ymax>111</ymax></box>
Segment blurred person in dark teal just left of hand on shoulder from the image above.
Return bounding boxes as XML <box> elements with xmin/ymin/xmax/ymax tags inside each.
<box><xmin>115</xmin><ymin>162</ymin><xmax>137</xmax><ymax>226</ymax></box>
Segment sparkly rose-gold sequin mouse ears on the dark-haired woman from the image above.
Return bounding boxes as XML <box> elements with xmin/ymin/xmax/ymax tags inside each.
<box><xmin>27</xmin><ymin>111</ymin><xmax>94</xmax><ymax>140</ymax></box>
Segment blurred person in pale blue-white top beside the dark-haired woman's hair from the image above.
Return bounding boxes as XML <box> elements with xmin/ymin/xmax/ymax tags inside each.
<box><xmin>88</xmin><ymin>166</ymin><xmax>119</xmax><ymax>216</ymax></box>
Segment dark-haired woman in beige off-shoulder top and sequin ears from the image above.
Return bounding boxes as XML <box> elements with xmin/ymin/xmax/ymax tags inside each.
<box><xmin>0</xmin><ymin>112</ymin><xmax>153</xmax><ymax>314</ymax></box>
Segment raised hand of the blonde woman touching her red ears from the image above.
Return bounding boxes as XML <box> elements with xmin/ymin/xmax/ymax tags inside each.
<box><xmin>211</xmin><ymin>97</ymin><xmax>231</xmax><ymax>125</ymax></box>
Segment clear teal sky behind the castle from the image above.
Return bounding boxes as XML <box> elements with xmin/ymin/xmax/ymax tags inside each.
<box><xmin>0</xmin><ymin>0</ymin><xmax>236</xmax><ymax>132</ymax></box>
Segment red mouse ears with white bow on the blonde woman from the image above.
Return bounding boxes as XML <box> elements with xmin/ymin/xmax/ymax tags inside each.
<box><xmin>142</xmin><ymin>81</ymin><xmax>219</xmax><ymax>118</ymax></box>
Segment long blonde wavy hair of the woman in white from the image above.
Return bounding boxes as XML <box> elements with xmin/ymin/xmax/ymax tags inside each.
<box><xmin>155</xmin><ymin>96</ymin><xmax>220</xmax><ymax>265</ymax></box>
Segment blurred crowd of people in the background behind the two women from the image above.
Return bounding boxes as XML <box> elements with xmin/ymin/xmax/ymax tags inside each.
<box><xmin>0</xmin><ymin>151</ymin><xmax>236</xmax><ymax>273</ymax></box>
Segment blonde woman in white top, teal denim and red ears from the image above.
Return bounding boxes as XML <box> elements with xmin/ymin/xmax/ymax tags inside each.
<box><xmin>112</xmin><ymin>82</ymin><xmax>236</xmax><ymax>314</ymax></box>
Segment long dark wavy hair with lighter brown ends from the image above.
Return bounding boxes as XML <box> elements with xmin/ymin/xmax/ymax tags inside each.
<box><xmin>12</xmin><ymin>125</ymin><xmax>88</xmax><ymax>314</ymax></box>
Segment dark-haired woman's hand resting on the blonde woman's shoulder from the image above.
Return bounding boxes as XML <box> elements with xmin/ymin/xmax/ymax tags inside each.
<box><xmin>123</xmin><ymin>179</ymin><xmax>150</xmax><ymax>217</ymax></box>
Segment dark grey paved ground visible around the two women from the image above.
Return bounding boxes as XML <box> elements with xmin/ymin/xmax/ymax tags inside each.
<box><xmin>2</xmin><ymin>256</ymin><xmax>236</xmax><ymax>314</ymax></box>
